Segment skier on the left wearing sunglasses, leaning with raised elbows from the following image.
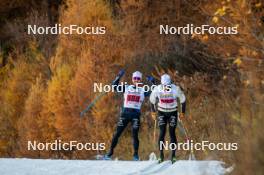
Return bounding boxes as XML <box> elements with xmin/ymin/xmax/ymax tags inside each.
<box><xmin>104</xmin><ymin>71</ymin><xmax>150</xmax><ymax>160</ymax></box>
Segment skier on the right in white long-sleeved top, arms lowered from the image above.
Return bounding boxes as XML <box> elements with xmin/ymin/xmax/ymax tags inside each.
<box><xmin>149</xmin><ymin>74</ymin><xmax>186</xmax><ymax>163</ymax></box>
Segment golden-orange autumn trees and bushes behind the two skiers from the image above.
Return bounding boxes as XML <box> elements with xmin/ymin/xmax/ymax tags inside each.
<box><xmin>0</xmin><ymin>0</ymin><xmax>264</xmax><ymax>174</ymax></box>
